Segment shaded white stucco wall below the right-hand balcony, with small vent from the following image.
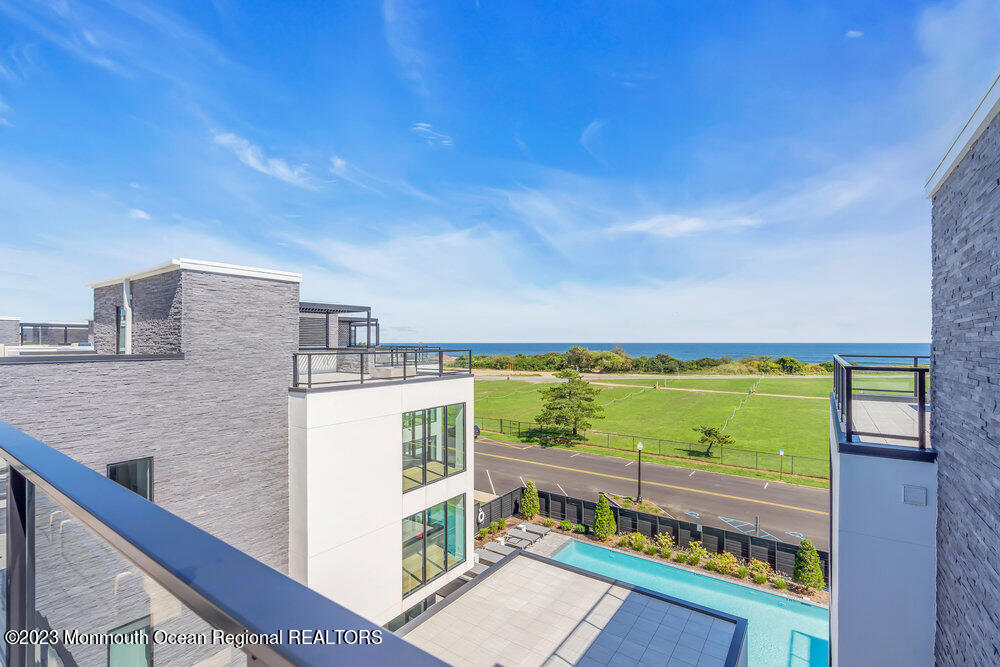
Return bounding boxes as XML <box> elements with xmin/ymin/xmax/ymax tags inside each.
<box><xmin>830</xmin><ymin>418</ymin><xmax>937</xmax><ymax>667</ymax></box>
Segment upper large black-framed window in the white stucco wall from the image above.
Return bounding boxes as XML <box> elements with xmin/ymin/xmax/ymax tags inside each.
<box><xmin>403</xmin><ymin>403</ymin><xmax>465</xmax><ymax>491</ymax></box>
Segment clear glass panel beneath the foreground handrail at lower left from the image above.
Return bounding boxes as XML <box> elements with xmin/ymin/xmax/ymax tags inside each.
<box><xmin>29</xmin><ymin>488</ymin><xmax>247</xmax><ymax>667</ymax></box>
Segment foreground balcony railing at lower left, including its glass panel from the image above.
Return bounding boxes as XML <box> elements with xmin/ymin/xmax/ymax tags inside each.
<box><xmin>0</xmin><ymin>422</ymin><xmax>443</xmax><ymax>666</ymax></box>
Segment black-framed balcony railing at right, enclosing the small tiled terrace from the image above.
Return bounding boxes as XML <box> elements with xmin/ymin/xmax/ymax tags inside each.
<box><xmin>833</xmin><ymin>354</ymin><xmax>930</xmax><ymax>449</ymax></box>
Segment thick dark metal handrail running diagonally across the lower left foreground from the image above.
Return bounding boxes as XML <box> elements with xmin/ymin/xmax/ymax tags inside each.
<box><xmin>0</xmin><ymin>422</ymin><xmax>443</xmax><ymax>665</ymax></box>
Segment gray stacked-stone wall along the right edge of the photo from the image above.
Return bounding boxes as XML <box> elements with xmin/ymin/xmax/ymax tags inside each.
<box><xmin>928</xmin><ymin>111</ymin><xmax>1000</xmax><ymax>665</ymax></box>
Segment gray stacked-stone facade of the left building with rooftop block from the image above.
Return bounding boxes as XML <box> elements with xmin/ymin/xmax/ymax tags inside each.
<box><xmin>0</xmin><ymin>270</ymin><xmax>299</xmax><ymax>572</ymax></box>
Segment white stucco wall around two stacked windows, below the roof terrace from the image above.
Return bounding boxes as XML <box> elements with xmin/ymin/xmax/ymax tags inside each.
<box><xmin>288</xmin><ymin>378</ymin><xmax>475</xmax><ymax>623</ymax></box>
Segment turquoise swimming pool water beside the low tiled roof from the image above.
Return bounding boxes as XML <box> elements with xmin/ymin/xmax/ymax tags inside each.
<box><xmin>554</xmin><ymin>541</ymin><xmax>830</xmax><ymax>667</ymax></box>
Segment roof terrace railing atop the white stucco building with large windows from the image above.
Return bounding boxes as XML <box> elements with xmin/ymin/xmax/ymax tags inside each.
<box><xmin>292</xmin><ymin>346</ymin><xmax>472</xmax><ymax>388</ymax></box>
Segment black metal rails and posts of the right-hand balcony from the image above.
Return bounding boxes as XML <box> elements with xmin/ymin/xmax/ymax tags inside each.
<box><xmin>833</xmin><ymin>354</ymin><xmax>930</xmax><ymax>449</ymax></box>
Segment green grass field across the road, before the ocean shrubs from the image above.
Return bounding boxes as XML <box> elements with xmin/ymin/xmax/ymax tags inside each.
<box><xmin>476</xmin><ymin>378</ymin><xmax>830</xmax><ymax>477</ymax></box>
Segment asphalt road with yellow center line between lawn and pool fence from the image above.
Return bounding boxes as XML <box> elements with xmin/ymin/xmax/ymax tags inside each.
<box><xmin>475</xmin><ymin>436</ymin><xmax>830</xmax><ymax>550</ymax></box>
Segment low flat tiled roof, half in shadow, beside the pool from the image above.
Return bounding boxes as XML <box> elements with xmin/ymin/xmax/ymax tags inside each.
<box><xmin>399</xmin><ymin>551</ymin><xmax>747</xmax><ymax>667</ymax></box>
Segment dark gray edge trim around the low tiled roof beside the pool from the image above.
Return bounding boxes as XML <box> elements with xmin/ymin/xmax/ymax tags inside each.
<box><xmin>396</xmin><ymin>545</ymin><xmax>747</xmax><ymax>667</ymax></box>
